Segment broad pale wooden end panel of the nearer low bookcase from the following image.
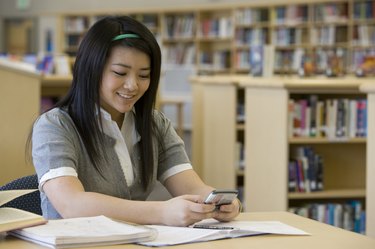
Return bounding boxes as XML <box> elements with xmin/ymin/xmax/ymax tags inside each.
<box><xmin>244</xmin><ymin>87</ymin><xmax>288</xmax><ymax>212</ymax></box>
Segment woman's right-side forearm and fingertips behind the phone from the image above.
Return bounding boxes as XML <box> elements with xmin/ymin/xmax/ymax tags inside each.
<box><xmin>164</xmin><ymin>170</ymin><xmax>241</xmax><ymax>221</ymax></box>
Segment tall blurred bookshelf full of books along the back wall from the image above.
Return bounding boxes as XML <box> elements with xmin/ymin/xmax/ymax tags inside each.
<box><xmin>54</xmin><ymin>0</ymin><xmax>375</xmax><ymax>75</ymax></box>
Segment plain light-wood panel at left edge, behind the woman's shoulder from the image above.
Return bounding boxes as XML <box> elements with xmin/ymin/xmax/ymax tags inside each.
<box><xmin>0</xmin><ymin>66</ymin><xmax>40</xmax><ymax>185</ymax></box>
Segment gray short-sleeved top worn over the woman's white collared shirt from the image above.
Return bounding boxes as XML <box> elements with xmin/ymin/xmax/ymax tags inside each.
<box><xmin>32</xmin><ymin>108</ymin><xmax>191</xmax><ymax>219</ymax></box>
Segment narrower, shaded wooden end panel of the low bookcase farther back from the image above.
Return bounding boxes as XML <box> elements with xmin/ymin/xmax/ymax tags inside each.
<box><xmin>202</xmin><ymin>85</ymin><xmax>236</xmax><ymax>188</ymax></box>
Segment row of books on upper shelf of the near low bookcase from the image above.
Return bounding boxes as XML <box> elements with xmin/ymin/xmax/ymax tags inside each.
<box><xmin>288</xmin><ymin>95</ymin><xmax>367</xmax><ymax>140</ymax></box>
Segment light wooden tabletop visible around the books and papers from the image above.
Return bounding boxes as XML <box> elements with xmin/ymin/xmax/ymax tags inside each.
<box><xmin>0</xmin><ymin>212</ymin><xmax>375</xmax><ymax>249</ymax></box>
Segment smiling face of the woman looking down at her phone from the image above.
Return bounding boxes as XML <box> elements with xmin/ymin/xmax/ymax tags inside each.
<box><xmin>100</xmin><ymin>46</ymin><xmax>151</xmax><ymax>121</ymax></box>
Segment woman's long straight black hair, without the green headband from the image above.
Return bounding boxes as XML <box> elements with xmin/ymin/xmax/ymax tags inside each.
<box><xmin>42</xmin><ymin>16</ymin><xmax>161</xmax><ymax>188</ymax></box>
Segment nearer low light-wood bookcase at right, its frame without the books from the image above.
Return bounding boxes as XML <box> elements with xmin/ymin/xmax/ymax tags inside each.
<box><xmin>240</xmin><ymin>77</ymin><xmax>373</xmax><ymax>234</ymax></box>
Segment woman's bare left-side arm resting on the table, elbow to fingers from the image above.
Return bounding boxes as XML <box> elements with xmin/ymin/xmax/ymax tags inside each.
<box><xmin>43</xmin><ymin>176</ymin><xmax>214</xmax><ymax>226</ymax></box>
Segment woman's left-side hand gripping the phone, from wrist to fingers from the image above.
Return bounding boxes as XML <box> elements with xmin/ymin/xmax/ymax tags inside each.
<box><xmin>162</xmin><ymin>195</ymin><xmax>215</xmax><ymax>226</ymax></box>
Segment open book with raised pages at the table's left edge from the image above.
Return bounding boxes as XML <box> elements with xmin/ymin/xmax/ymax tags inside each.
<box><xmin>0</xmin><ymin>189</ymin><xmax>47</xmax><ymax>233</ymax></box>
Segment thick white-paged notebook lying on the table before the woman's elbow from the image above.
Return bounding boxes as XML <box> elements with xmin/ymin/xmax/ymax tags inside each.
<box><xmin>10</xmin><ymin>216</ymin><xmax>156</xmax><ymax>248</ymax></box>
